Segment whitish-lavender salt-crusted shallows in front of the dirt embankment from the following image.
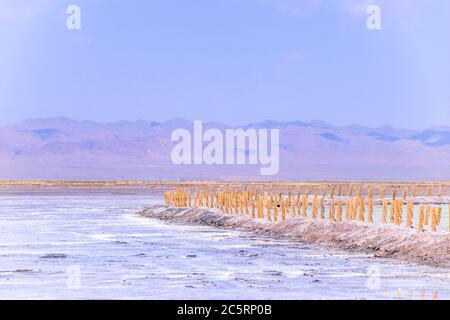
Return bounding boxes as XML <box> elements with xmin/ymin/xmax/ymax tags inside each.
<box><xmin>0</xmin><ymin>192</ymin><xmax>450</xmax><ymax>299</ymax></box>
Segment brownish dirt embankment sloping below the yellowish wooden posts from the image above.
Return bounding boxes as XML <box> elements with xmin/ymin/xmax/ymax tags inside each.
<box><xmin>139</xmin><ymin>206</ymin><xmax>450</xmax><ymax>268</ymax></box>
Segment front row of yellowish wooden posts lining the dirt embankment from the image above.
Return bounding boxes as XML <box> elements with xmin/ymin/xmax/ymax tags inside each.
<box><xmin>164</xmin><ymin>189</ymin><xmax>450</xmax><ymax>232</ymax></box>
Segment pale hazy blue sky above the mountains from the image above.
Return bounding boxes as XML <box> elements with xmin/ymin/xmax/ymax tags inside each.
<box><xmin>0</xmin><ymin>0</ymin><xmax>450</xmax><ymax>128</ymax></box>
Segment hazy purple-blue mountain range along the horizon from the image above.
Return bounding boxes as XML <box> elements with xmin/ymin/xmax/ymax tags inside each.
<box><xmin>0</xmin><ymin>118</ymin><xmax>450</xmax><ymax>181</ymax></box>
